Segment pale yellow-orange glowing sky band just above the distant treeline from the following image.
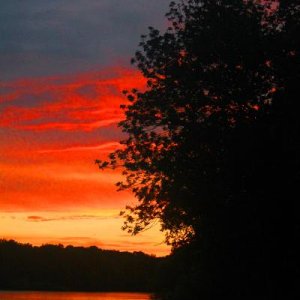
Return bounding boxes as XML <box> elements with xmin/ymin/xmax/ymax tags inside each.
<box><xmin>0</xmin><ymin>209</ymin><xmax>170</xmax><ymax>256</ymax></box>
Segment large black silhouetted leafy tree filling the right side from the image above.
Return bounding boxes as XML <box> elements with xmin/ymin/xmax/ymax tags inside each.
<box><xmin>98</xmin><ymin>0</ymin><xmax>300</xmax><ymax>299</ymax></box>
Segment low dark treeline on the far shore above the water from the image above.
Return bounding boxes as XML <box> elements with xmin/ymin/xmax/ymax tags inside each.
<box><xmin>0</xmin><ymin>240</ymin><xmax>164</xmax><ymax>292</ymax></box>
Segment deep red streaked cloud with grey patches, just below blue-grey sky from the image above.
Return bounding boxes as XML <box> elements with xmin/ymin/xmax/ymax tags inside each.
<box><xmin>0</xmin><ymin>67</ymin><xmax>145</xmax><ymax>131</ymax></box>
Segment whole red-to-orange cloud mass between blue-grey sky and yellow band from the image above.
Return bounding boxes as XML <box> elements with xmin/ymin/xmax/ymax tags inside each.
<box><xmin>0</xmin><ymin>67</ymin><xmax>145</xmax><ymax>211</ymax></box>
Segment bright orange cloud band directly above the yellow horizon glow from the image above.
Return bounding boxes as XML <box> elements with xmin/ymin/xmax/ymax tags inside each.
<box><xmin>0</xmin><ymin>162</ymin><xmax>133</xmax><ymax>211</ymax></box>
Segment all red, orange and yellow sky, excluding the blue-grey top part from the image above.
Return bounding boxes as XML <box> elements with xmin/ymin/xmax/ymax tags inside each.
<box><xmin>0</xmin><ymin>67</ymin><xmax>170</xmax><ymax>256</ymax></box>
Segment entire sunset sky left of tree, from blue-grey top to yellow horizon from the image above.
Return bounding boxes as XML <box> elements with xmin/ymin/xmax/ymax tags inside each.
<box><xmin>0</xmin><ymin>0</ymin><xmax>170</xmax><ymax>256</ymax></box>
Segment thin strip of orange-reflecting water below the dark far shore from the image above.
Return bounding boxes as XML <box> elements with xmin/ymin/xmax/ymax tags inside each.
<box><xmin>0</xmin><ymin>291</ymin><xmax>151</xmax><ymax>300</ymax></box>
